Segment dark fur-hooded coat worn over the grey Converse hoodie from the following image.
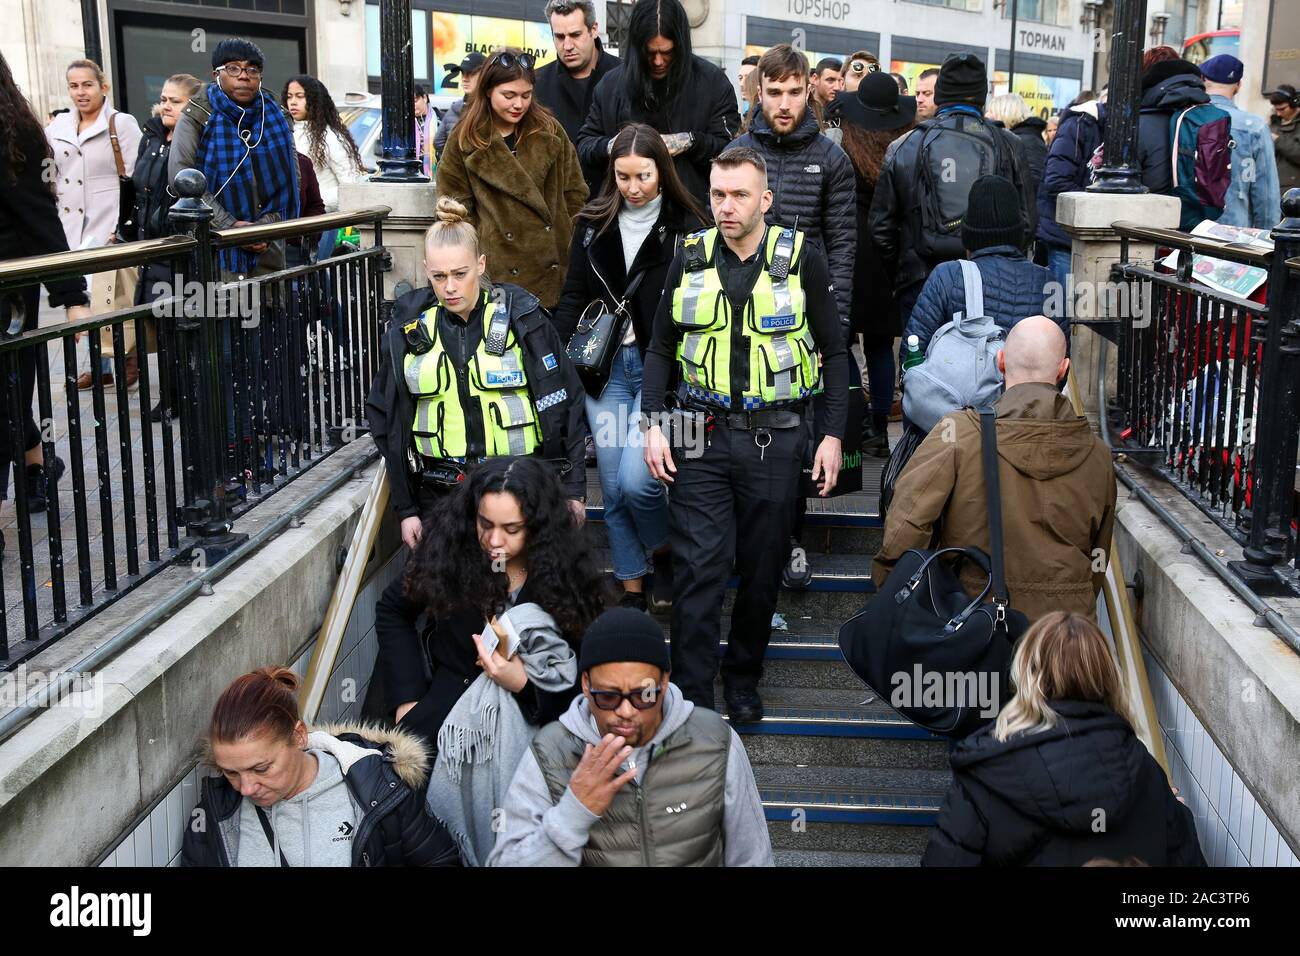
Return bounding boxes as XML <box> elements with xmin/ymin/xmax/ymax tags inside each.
<box><xmin>181</xmin><ymin>724</ymin><xmax>460</xmax><ymax>866</ymax></box>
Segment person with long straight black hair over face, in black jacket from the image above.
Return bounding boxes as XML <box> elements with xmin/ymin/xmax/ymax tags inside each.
<box><xmin>577</xmin><ymin>0</ymin><xmax>740</xmax><ymax>209</ymax></box>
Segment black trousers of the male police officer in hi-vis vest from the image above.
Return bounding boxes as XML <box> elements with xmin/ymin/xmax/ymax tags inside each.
<box><xmin>668</xmin><ymin>424</ymin><xmax>807</xmax><ymax>709</ymax></box>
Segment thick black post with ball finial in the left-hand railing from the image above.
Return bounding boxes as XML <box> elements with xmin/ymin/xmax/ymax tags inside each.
<box><xmin>168</xmin><ymin>169</ymin><xmax>248</xmax><ymax>561</ymax></box>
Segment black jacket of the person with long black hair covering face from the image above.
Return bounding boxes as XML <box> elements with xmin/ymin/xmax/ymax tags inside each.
<box><xmin>577</xmin><ymin>55</ymin><xmax>740</xmax><ymax>211</ymax></box>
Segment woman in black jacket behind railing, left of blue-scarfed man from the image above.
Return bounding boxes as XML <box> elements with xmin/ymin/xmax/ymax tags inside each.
<box><xmin>114</xmin><ymin>73</ymin><xmax>203</xmax><ymax>421</ymax></box>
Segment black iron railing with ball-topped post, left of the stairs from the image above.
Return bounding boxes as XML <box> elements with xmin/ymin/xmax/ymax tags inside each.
<box><xmin>0</xmin><ymin>170</ymin><xmax>389</xmax><ymax>667</ymax></box>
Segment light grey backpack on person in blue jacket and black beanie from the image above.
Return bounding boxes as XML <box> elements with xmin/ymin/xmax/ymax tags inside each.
<box><xmin>902</xmin><ymin>259</ymin><xmax>1006</xmax><ymax>432</ymax></box>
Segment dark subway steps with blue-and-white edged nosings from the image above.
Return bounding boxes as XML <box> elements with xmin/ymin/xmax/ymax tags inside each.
<box><xmin>588</xmin><ymin>459</ymin><xmax>949</xmax><ymax>866</ymax></box>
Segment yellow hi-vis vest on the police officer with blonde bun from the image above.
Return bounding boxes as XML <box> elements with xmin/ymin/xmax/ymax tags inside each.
<box><xmin>402</xmin><ymin>300</ymin><xmax>541</xmax><ymax>458</ymax></box>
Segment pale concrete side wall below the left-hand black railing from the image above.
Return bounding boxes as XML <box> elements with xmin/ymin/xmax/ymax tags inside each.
<box><xmin>0</xmin><ymin>438</ymin><xmax>393</xmax><ymax>866</ymax></box>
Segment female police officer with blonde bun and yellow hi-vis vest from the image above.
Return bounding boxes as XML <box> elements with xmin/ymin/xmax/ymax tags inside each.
<box><xmin>365</xmin><ymin>198</ymin><xmax>586</xmax><ymax>549</ymax></box>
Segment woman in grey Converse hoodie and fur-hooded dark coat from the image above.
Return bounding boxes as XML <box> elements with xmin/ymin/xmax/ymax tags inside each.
<box><xmin>181</xmin><ymin>667</ymin><xmax>460</xmax><ymax>866</ymax></box>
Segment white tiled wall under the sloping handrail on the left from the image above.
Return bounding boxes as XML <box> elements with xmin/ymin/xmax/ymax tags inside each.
<box><xmin>100</xmin><ymin>549</ymin><xmax>406</xmax><ymax>866</ymax></box>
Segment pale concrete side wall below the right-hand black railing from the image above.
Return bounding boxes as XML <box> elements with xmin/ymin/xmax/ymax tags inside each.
<box><xmin>1115</xmin><ymin>468</ymin><xmax>1300</xmax><ymax>864</ymax></box>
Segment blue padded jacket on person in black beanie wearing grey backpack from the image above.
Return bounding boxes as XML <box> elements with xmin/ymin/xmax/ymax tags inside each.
<box><xmin>904</xmin><ymin>246</ymin><xmax>1070</xmax><ymax>351</ymax></box>
